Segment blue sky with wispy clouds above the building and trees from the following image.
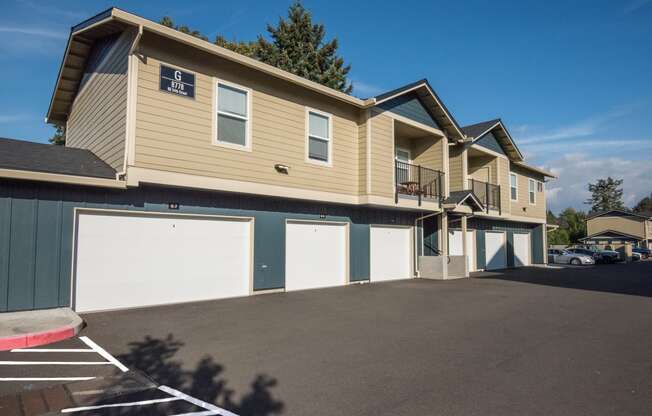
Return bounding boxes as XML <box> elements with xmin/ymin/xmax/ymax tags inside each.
<box><xmin>0</xmin><ymin>0</ymin><xmax>652</xmax><ymax>212</ymax></box>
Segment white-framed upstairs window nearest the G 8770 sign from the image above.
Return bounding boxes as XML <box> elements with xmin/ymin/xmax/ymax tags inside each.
<box><xmin>215</xmin><ymin>81</ymin><xmax>251</xmax><ymax>149</ymax></box>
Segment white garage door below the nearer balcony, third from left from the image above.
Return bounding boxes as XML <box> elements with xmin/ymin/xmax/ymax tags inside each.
<box><xmin>370</xmin><ymin>225</ymin><xmax>412</xmax><ymax>282</ymax></box>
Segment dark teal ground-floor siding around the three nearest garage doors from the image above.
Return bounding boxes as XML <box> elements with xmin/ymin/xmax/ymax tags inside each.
<box><xmin>0</xmin><ymin>181</ymin><xmax>417</xmax><ymax>312</ymax></box>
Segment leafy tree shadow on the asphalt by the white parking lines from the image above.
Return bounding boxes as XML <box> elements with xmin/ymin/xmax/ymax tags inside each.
<box><xmin>102</xmin><ymin>334</ymin><xmax>284</xmax><ymax>416</ymax></box>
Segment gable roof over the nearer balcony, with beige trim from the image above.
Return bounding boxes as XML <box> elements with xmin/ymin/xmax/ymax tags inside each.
<box><xmin>367</xmin><ymin>78</ymin><xmax>465</xmax><ymax>140</ymax></box>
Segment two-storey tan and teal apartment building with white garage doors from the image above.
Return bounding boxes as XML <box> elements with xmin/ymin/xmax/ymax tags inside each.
<box><xmin>0</xmin><ymin>8</ymin><xmax>552</xmax><ymax>312</ymax></box>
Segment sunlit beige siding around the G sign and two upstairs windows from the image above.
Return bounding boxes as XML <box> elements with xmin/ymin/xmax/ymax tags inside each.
<box><xmin>135</xmin><ymin>35</ymin><xmax>361</xmax><ymax>195</ymax></box>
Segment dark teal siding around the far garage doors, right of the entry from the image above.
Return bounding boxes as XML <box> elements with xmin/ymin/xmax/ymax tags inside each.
<box><xmin>468</xmin><ymin>218</ymin><xmax>544</xmax><ymax>269</ymax></box>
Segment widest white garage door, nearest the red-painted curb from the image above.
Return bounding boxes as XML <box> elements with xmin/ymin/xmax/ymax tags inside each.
<box><xmin>74</xmin><ymin>213</ymin><xmax>252</xmax><ymax>312</ymax></box>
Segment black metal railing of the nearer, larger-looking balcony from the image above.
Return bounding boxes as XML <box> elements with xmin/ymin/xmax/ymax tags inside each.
<box><xmin>394</xmin><ymin>161</ymin><xmax>444</xmax><ymax>205</ymax></box>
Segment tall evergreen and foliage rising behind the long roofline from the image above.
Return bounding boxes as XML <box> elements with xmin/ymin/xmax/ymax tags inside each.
<box><xmin>160</xmin><ymin>1</ymin><xmax>353</xmax><ymax>94</ymax></box>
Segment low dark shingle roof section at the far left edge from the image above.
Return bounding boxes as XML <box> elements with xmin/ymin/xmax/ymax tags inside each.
<box><xmin>0</xmin><ymin>138</ymin><xmax>116</xmax><ymax>179</ymax></box>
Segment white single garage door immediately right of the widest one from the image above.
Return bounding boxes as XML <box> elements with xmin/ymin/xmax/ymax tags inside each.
<box><xmin>285</xmin><ymin>221</ymin><xmax>348</xmax><ymax>290</ymax></box>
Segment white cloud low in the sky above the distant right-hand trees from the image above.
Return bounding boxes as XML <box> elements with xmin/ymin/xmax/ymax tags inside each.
<box><xmin>546</xmin><ymin>153</ymin><xmax>652</xmax><ymax>212</ymax></box>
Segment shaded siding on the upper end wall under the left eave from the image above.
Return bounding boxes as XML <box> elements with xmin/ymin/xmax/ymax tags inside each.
<box><xmin>66</xmin><ymin>31</ymin><xmax>135</xmax><ymax>171</ymax></box>
